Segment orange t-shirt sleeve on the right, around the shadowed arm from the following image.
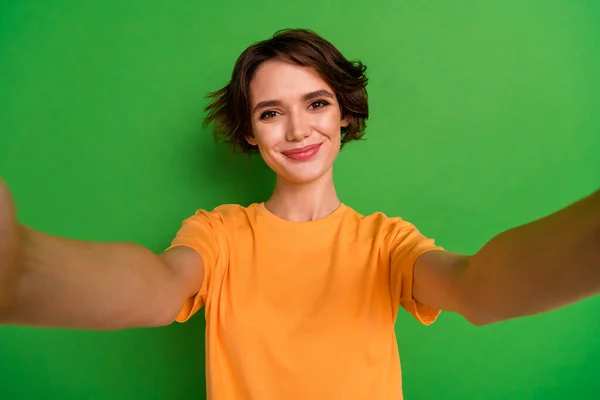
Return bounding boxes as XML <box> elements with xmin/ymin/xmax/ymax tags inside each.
<box><xmin>389</xmin><ymin>219</ymin><xmax>443</xmax><ymax>325</ymax></box>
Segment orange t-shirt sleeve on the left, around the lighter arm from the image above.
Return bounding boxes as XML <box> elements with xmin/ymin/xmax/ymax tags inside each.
<box><xmin>167</xmin><ymin>210</ymin><xmax>219</xmax><ymax>322</ymax></box>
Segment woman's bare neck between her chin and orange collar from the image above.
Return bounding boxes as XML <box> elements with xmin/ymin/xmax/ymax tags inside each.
<box><xmin>265</xmin><ymin>169</ymin><xmax>341</xmax><ymax>222</ymax></box>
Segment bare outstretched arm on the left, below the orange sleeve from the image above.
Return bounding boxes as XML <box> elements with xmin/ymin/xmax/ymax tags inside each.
<box><xmin>0</xmin><ymin>181</ymin><xmax>204</xmax><ymax>330</ymax></box>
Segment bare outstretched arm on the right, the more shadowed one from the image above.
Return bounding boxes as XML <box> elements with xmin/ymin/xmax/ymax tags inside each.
<box><xmin>413</xmin><ymin>191</ymin><xmax>600</xmax><ymax>325</ymax></box>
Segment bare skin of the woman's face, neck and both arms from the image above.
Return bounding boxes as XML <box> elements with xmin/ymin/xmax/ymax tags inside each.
<box><xmin>0</xmin><ymin>60</ymin><xmax>600</xmax><ymax>330</ymax></box>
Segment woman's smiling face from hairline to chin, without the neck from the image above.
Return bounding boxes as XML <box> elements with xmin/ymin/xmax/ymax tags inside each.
<box><xmin>246</xmin><ymin>59</ymin><xmax>348</xmax><ymax>183</ymax></box>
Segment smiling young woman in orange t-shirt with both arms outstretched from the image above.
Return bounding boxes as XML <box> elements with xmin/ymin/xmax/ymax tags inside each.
<box><xmin>0</xmin><ymin>30</ymin><xmax>600</xmax><ymax>400</ymax></box>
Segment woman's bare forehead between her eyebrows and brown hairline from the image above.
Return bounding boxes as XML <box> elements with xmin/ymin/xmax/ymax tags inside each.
<box><xmin>250</xmin><ymin>59</ymin><xmax>333</xmax><ymax>103</ymax></box>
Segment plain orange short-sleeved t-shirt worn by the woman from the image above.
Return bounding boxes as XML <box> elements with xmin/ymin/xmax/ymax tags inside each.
<box><xmin>166</xmin><ymin>203</ymin><xmax>441</xmax><ymax>400</ymax></box>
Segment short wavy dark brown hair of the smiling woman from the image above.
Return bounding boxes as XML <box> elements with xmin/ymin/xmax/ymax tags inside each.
<box><xmin>204</xmin><ymin>29</ymin><xmax>369</xmax><ymax>153</ymax></box>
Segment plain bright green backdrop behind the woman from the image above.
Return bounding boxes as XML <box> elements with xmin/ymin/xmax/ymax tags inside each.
<box><xmin>0</xmin><ymin>0</ymin><xmax>600</xmax><ymax>400</ymax></box>
